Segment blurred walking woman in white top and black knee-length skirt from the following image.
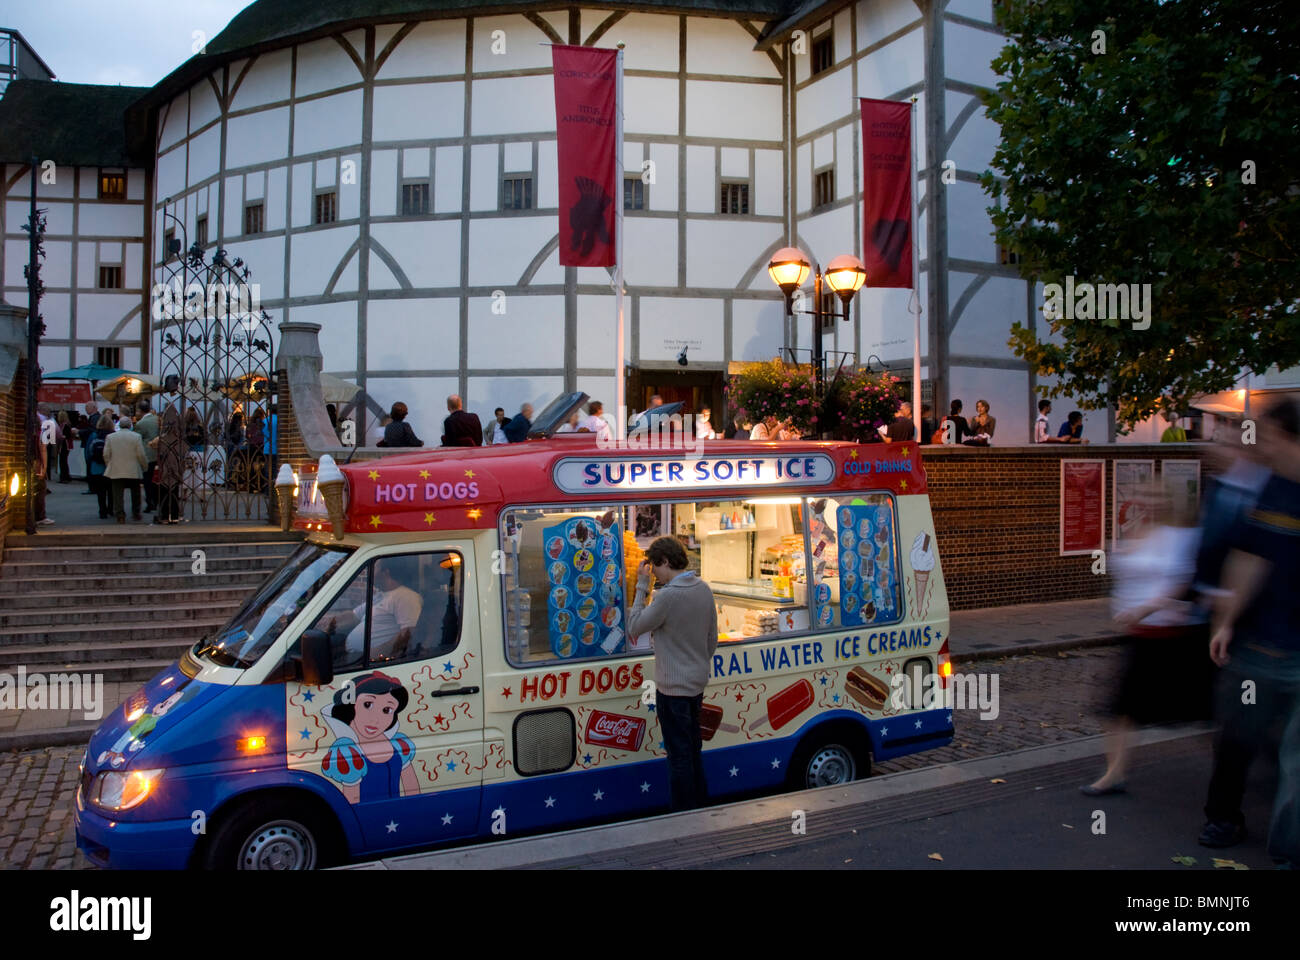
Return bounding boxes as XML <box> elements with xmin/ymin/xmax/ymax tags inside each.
<box><xmin>1079</xmin><ymin>485</ymin><xmax>1214</xmax><ymax>796</ymax></box>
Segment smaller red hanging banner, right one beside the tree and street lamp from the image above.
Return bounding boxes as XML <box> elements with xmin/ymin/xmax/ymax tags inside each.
<box><xmin>862</xmin><ymin>98</ymin><xmax>914</xmax><ymax>287</ymax></box>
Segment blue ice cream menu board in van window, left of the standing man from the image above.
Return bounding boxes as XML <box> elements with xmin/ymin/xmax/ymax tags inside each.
<box><xmin>542</xmin><ymin>510</ymin><xmax>625</xmax><ymax>658</ymax></box>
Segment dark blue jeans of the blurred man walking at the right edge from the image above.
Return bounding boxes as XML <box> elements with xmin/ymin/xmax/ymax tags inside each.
<box><xmin>1205</xmin><ymin>640</ymin><xmax>1300</xmax><ymax>866</ymax></box>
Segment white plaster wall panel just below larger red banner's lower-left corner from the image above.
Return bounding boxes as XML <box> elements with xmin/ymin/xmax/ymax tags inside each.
<box><xmin>470</xmin><ymin>287</ymin><xmax>564</xmax><ymax>368</ymax></box>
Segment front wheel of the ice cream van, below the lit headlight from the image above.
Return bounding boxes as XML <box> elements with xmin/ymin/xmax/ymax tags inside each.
<box><xmin>203</xmin><ymin>800</ymin><xmax>333</xmax><ymax>870</ymax></box>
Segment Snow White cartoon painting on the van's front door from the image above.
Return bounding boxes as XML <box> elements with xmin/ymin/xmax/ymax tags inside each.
<box><xmin>321</xmin><ymin>670</ymin><xmax>420</xmax><ymax>804</ymax></box>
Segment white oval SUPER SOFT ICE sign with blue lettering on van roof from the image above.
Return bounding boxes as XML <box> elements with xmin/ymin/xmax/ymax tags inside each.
<box><xmin>555</xmin><ymin>454</ymin><xmax>835</xmax><ymax>493</ymax></box>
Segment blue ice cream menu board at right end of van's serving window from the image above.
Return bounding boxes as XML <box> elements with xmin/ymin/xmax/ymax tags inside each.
<box><xmin>832</xmin><ymin>503</ymin><xmax>897</xmax><ymax>627</ymax></box>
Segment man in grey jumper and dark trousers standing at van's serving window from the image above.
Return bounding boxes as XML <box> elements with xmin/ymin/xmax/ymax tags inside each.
<box><xmin>628</xmin><ymin>537</ymin><xmax>718</xmax><ymax>810</ymax></box>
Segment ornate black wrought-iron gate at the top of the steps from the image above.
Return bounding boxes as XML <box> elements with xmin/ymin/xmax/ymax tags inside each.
<box><xmin>151</xmin><ymin>209</ymin><xmax>276</xmax><ymax>522</ymax></box>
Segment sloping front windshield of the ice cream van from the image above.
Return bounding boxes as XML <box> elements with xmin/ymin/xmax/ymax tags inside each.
<box><xmin>194</xmin><ymin>544</ymin><xmax>352</xmax><ymax>667</ymax></box>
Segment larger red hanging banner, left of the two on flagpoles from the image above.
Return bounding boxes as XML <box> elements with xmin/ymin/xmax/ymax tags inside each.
<box><xmin>551</xmin><ymin>47</ymin><xmax>621</xmax><ymax>267</ymax></box>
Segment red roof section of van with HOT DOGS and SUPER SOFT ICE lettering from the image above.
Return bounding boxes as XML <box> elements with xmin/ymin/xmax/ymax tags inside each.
<box><xmin>294</xmin><ymin>433</ymin><xmax>927</xmax><ymax>533</ymax></box>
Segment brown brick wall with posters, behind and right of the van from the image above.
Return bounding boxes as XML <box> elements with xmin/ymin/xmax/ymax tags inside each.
<box><xmin>922</xmin><ymin>444</ymin><xmax>1206</xmax><ymax>610</ymax></box>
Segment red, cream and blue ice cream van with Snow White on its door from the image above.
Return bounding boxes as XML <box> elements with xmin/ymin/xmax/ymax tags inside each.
<box><xmin>75</xmin><ymin>394</ymin><xmax>953</xmax><ymax>869</ymax></box>
